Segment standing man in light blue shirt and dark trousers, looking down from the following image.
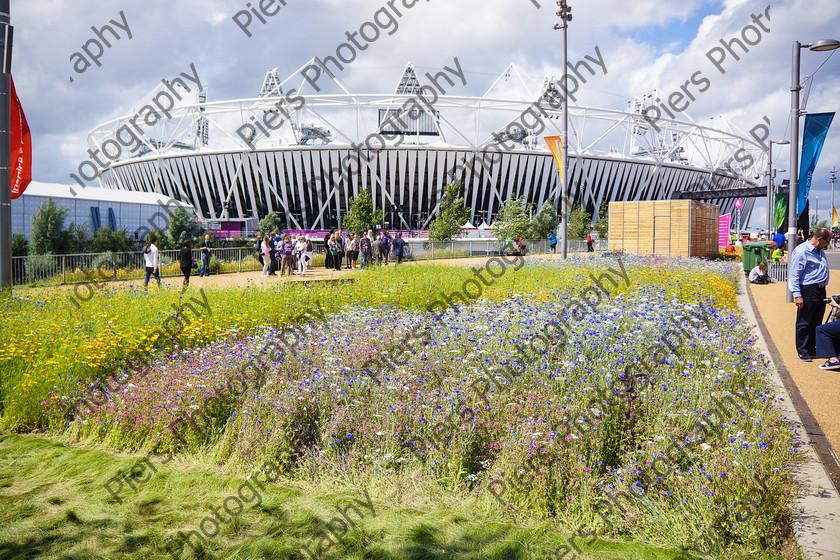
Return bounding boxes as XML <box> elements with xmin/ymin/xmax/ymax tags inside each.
<box><xmin>788</xmin><ymin>228</ymin><xmax>831</xmax><ymax>362</ymax></box>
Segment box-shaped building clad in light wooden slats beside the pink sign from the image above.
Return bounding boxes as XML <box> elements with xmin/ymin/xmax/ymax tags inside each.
<box><xmin>609</xmin><ymin>200</ymin><xmax>720</xmax><ymax>257</ymax></box>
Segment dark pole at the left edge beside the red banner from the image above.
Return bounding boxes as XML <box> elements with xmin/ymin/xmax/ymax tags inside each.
<box><xmin>0</xmin><ymin>0</ymin><xmax>12</xmax><ymax>291</ymax></box>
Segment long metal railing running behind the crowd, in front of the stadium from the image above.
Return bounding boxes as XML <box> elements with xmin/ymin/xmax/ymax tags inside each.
<box><xmin>12</xmin><ymin>238</ymin><xmax>607</xmax><ymax>286</ymax></box>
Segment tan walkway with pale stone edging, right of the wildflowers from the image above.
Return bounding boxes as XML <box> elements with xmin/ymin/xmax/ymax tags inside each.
<box><xmin>740</xmin><ymin>277</ymin><xmax>840</xmax><ymax>559</ymax></box>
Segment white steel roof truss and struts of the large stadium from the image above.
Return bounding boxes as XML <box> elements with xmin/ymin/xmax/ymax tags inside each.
<box><xmin>88</xmin><ymin>59</ymin><xmax>765</xmax><ymax>227</ymax></box>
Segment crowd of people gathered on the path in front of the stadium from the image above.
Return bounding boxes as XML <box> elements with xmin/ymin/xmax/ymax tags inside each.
<box><xmin>254</xmin><ymin>230</ymin><xmax>406</xmax><ymax>277</ymax></box>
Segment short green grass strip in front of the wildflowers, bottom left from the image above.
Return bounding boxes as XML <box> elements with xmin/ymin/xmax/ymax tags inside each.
<box><xmin>0</xmin><ymin>434</ymin><xmax>704</xmax><ymax>560</ymax></box>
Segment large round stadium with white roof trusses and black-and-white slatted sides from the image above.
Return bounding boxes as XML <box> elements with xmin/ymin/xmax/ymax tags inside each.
<box><xmin>88</xmin><ymin>63</ymin><xmax>765</xmax><ymax>234</ymax></box>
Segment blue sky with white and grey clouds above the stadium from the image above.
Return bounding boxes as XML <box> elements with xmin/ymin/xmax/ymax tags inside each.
<box><xmin>12</xmin><ymin>0</ymin><xmax>840</xmax><ymax>229</ymax></box>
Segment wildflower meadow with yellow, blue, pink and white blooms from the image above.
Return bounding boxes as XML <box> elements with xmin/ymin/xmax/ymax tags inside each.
<box><xmin>0</xmin><ymin>256</ymin><xmax>799</xmax><ymax>559</ymax></box>
